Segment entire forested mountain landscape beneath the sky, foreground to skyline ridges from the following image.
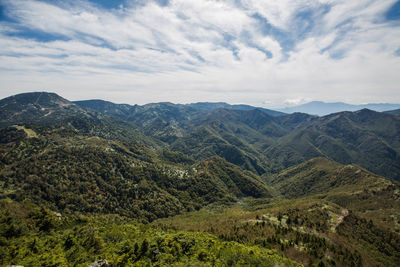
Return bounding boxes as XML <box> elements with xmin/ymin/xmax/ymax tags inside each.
<box><xmin>0</xmin><ymin>93</ymin><xmax>400</xmax><ymax>266</ymax></box>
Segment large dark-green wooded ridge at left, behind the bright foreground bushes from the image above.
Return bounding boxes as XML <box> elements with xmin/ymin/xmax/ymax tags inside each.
<box><xmin>0</xmin><ymin>128</ymin><xmax>271</xmax><ymax>221</ymax></box>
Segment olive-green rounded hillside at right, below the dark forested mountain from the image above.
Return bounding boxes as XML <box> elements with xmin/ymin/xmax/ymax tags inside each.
<box><xmin>271</xmin><ymin>158</ymin><xmax>400</xmax><ymax>233</ymax></box>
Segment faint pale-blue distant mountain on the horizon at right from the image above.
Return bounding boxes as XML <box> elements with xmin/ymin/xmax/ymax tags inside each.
<box><xmin>279</xmin><ymin>101</ymin><xmax>400</xmax><ymax>116</ymax></box>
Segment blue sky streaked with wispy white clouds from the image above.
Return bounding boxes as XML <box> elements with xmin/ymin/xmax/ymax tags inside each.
<box><xmin>0</xmin><ymin>0</ymin><xmax>400</xmax><ymax>108</ymax></box>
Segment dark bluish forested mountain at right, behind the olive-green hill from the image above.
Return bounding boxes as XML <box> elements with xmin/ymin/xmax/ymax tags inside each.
<box><xmin>264</xmin><ymin>110</ymin><xmax>400</xmax><ymax>180</ymax></box>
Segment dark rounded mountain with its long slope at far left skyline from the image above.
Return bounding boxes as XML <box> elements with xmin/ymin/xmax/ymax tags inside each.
<box><xmin>0</xmin><ymin>92</ymin><xmax>162</xmax><ymax>147</ymax></box>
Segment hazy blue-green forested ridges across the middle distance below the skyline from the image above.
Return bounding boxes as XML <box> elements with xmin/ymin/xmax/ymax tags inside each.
<box><xmin>78</xmin><ymin>97</ymin><xmax>400</xmax><ymax>180</ymax></box>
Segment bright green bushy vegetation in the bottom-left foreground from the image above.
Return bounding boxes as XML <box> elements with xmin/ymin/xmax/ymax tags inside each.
<box><xmin>0</xmin><ymin>201</ymin><xmax>297</xmax><ymax>266</ymax></box>
